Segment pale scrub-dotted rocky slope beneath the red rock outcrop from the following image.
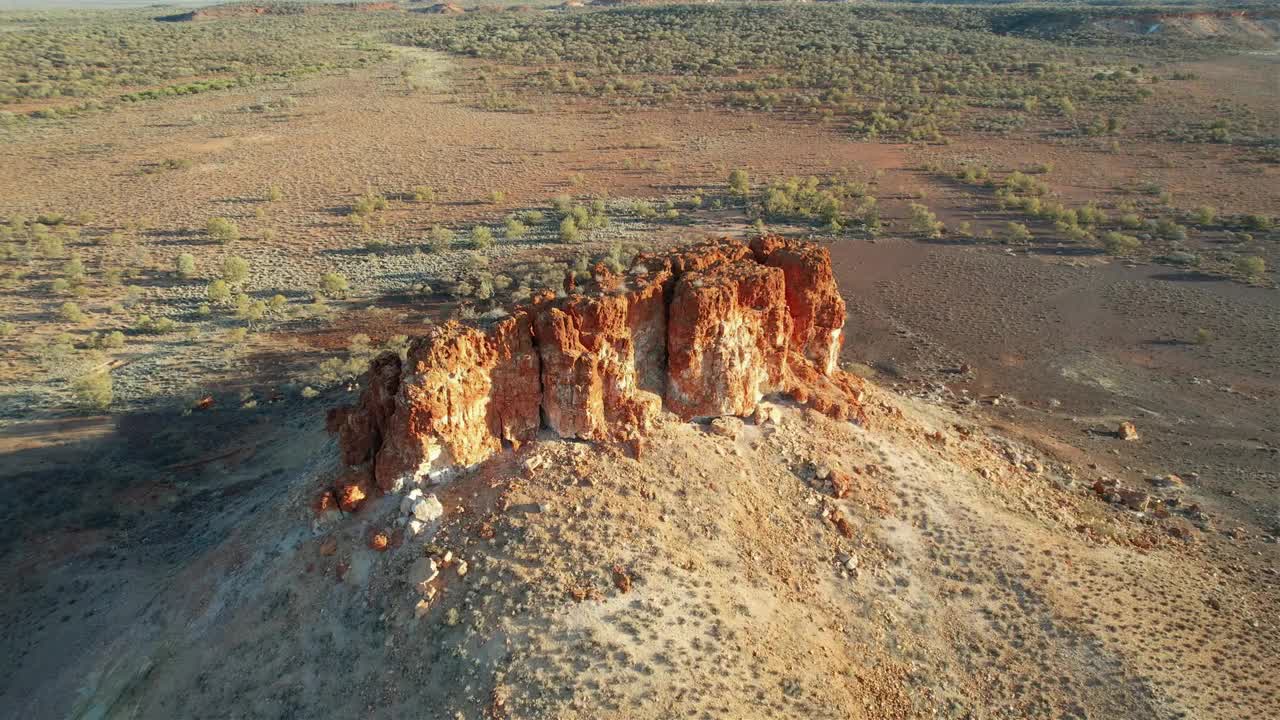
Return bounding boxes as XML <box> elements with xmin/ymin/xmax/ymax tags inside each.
<box><xmin>55</xmin><ymin>361</ymin><xmax>1280</xmax><ymax>720</ymax></box>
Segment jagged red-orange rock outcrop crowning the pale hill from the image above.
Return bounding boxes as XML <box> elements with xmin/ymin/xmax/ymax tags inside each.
<box><xmin>328</xmin><ymin>236</ymin><xmax>860</xmax><ymax>492</ymax></box>
